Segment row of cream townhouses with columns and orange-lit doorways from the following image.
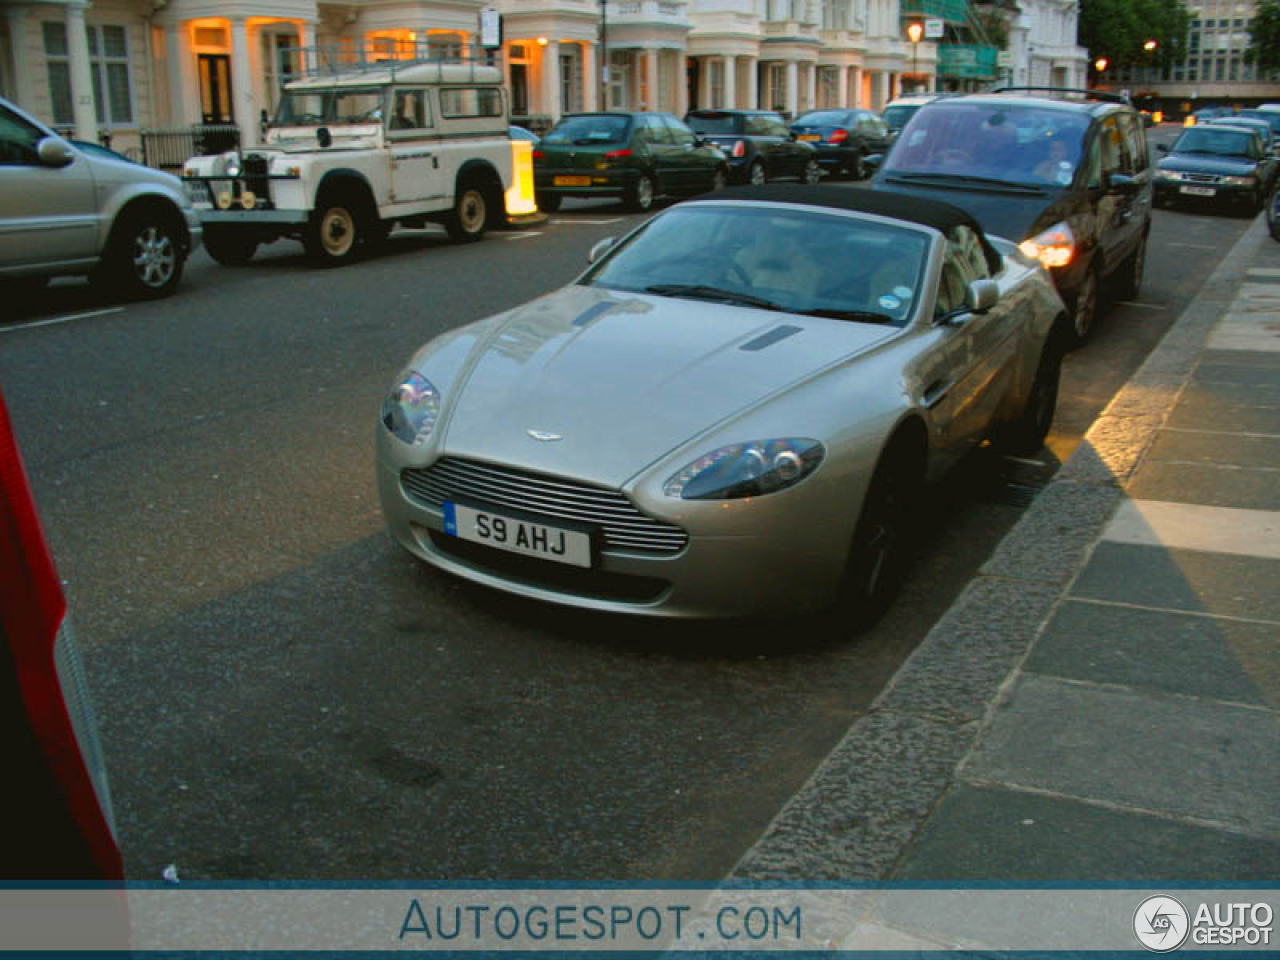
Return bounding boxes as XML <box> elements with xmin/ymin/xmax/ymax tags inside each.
<box><xmin>0</xmin><ymin>0</ymin><xmax>936</xmax><ymax>161</ymax></box>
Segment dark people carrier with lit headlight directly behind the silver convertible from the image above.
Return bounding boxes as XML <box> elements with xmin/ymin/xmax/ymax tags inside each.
<box><xmin>873</xmin><ymin>88</ymin><xmax>1153</xmax><ymax>343</ymax></box>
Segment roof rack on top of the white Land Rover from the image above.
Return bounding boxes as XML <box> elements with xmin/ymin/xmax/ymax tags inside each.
<box><xmin>283</xmin><ymin>40</ymin><xmax>502</xmax><ymax>82</ymax></box>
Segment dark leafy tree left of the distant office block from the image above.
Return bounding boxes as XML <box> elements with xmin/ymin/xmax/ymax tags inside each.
<box><xmin>1079</xmin><ymin>0</ymin><xmax>1187</xmax><ymax>69</ymax></box>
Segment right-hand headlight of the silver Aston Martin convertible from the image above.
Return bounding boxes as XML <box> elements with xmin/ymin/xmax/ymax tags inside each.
<box><xmin>662</xmin><ymin>436</ymin><xmax>827</xmax><ymax>500</ymax></box>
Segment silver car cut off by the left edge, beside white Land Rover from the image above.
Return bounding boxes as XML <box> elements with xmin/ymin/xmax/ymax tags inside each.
<box><xmin>0</xmin><ymin>99</ymin><xmax>201</xmax><ymax>298</ymax></box>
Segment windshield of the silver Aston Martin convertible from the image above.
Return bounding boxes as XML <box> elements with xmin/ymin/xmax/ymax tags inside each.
<box><xmin>582</xmin><ymin>205</ymin><xmax>929</xmax><ymax>325</ymax></box>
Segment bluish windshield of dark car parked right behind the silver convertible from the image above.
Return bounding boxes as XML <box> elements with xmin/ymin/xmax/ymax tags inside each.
<box><xmin>884</xmin><ymin>104</ymin><xmax>1088</xmax><ymax>187</ymax></box>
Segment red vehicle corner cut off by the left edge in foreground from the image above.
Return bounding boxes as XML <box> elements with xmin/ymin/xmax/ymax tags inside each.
<box><xmin>0</xmin><ymin>386</ymin><xmax>124</xmax><ymax>881</ymax></box>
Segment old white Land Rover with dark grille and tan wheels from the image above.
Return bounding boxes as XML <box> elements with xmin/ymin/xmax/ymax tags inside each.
<box><xmin>183</xmin><ymin>51</ymin><xmax>512</xmax><ymax>266</ymax></box>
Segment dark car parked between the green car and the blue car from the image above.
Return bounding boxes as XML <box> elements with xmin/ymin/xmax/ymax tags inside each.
<box><xmin>685</xmin><ymin>110</ymin><xmax>822</xmax><ymax>184</ymax></box>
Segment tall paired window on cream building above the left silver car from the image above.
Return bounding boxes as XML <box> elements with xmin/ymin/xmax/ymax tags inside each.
<box><xmin>42</xmin><ymin>23</ymin><xmax>133</xmax><ymax>127</ymax></box>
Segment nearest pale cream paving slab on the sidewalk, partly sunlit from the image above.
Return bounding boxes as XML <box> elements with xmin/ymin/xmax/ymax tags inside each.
<box><xmin>1102</xmin><ymin>500</ymin><xmax>1280</xmax><ymax>559</ymax></box>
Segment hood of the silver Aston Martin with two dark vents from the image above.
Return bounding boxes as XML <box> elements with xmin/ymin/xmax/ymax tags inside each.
<box><xmin>426</xmin><ymin>285</ymin><xmax>900</xmax><ymax>486</ymax></box>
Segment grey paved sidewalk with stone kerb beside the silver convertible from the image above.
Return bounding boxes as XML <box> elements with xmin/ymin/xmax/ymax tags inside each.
<box><xmin>733</xmin><ymin>218</ymin><xmax>1280</xmax><ymax>911</ymax></box>
